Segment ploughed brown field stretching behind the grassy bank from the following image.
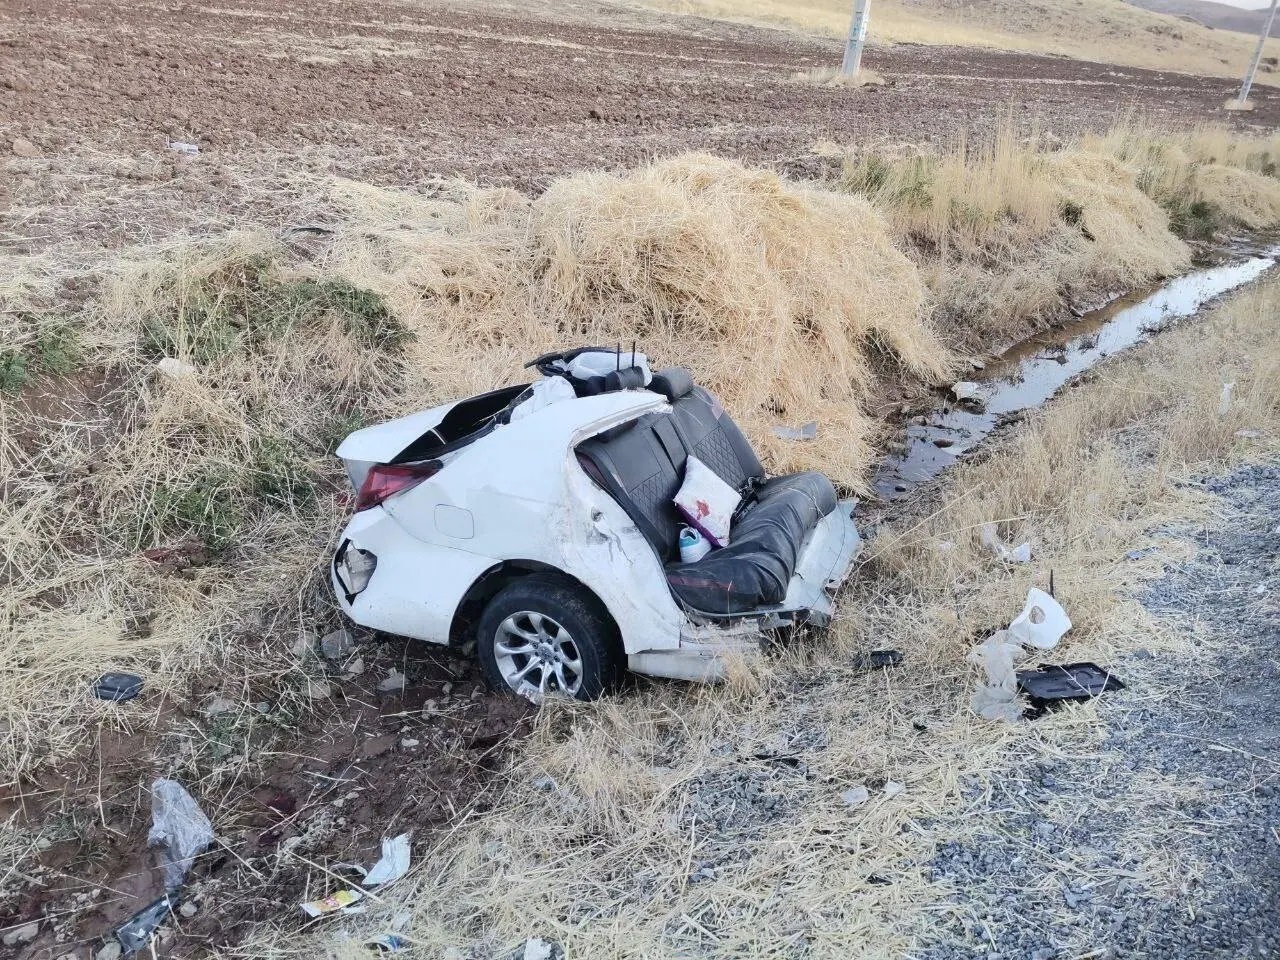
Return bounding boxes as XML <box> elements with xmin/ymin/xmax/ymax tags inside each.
<box><xmin>0</xmin><ymin>0</ymin><xmax>1280</xmax><ymax>259</ymax></box>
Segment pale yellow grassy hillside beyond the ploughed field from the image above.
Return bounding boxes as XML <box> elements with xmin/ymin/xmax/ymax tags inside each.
<box><xmin>645</xmin><ymin>0</ymin><xmax>1280</xmax><ymax>84</ymax></box>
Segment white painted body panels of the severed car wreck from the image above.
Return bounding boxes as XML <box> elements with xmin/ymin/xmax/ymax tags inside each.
<box><xmin>330</xmin><ymin>389</ymin><xmax>860</xmax><ymax>681</ymax></box>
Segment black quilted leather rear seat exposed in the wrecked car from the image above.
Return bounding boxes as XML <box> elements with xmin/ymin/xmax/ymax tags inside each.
<box><xmin>577</xmin><ymin>367</ymin><xmax>836</xmax><ymax>614</ymax></box>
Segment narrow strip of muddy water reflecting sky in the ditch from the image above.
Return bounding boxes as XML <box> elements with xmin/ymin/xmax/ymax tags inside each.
<box><xmin>874</xmin><ymin>244</ymin><xmax>1280</xmax><ymax>500</ymax></box>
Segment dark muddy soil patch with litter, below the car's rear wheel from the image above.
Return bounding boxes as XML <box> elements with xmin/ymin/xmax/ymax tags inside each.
<box><xmin>0</xmin><ymin>632</ymin><xmax>532</xmax><ymax>960</ymax></box>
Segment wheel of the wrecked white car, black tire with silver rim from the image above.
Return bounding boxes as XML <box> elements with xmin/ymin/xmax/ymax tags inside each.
<box><xmin>476</xmin><ymin>573</ymin><xmax>626</xmax><ymax>700</ymax></box>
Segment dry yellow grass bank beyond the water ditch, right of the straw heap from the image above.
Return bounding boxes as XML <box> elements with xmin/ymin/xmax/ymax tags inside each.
<box><xmin>824</xmin><ymin>123</ymin><xmax>1280</xmax><ymax>349</ymax></box>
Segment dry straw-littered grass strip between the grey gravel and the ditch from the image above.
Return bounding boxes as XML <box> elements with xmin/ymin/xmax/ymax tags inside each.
<box><xmin>225</xmin><ymin>263</ymin><xmax>1280</xmax><ymax>960</ymax></box>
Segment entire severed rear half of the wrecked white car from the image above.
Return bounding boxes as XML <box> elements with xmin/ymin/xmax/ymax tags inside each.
<box><xmin>332</xmin><ymin>348</ymin><xmax>861</xmax><ymax>700</ymax></box>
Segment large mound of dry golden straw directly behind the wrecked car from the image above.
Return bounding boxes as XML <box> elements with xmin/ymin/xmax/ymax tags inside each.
<box><xmin>317</xmin><ymin>155</ymin><xmax>951</xmax><ymax>486</ymax></box>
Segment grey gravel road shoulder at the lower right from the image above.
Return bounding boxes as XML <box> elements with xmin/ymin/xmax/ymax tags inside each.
<box><xmin>913</xmin><ymin>465</ymin><xmax>1280</xmax><ymax>960</ymax></box>
